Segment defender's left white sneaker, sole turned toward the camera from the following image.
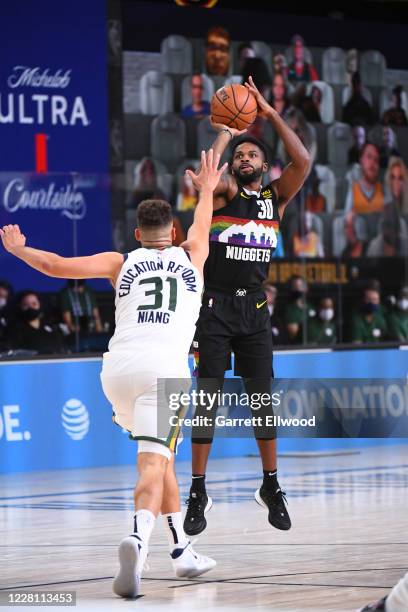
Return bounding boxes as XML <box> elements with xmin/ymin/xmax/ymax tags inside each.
<box><xmin>112</xmin><ymin>533</ymin><xmax>148</xmax><ymax>597</ymax></box>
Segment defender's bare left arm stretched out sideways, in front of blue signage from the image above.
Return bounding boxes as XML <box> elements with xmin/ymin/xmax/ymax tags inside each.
<box><xmin>0</xmin><ymin>225</ymin><xmax>123</xmax><ymax>282</ymax></box>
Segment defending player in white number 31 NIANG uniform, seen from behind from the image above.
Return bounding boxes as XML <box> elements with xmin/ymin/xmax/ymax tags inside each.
<box><xmin>0</xmin><ymin>150</ymin><xmax>226</xmax><ymax>597</ymax></box>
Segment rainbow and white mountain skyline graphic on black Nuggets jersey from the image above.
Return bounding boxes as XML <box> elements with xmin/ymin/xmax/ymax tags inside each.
<box><xmin>210</xmin><ymin>216</ymin><xmax>279</xmax><ymax>248</ymax></box>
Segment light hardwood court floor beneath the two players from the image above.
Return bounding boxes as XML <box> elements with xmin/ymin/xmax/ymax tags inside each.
<box><xmin>0</xmin><ymin>445</ymin><xmax>408</xmax><ymax>612</ymax></box>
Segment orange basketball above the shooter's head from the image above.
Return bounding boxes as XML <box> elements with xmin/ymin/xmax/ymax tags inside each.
<box><xmin>211</xmin><ymin>83</ymin><xmax>258</xmax><ymax>130</ymax></box>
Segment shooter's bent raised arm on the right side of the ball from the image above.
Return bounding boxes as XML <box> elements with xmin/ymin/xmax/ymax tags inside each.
<box><xmin>245</xmin><ymin>77</ymin><xmax>310</xmax><ymax>218</ymax></box>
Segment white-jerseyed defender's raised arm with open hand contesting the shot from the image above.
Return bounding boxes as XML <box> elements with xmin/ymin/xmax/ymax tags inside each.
<box><xmin>181</xmin><ymin>149</ymin><xmax>228</xmax><ymax>273</ymax></box>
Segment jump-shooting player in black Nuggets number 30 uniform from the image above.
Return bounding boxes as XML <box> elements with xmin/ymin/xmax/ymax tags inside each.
<box><xmin>184</xmin><ymin>77</ymin><xmax>310</xmax><ymax>535</ymax></box>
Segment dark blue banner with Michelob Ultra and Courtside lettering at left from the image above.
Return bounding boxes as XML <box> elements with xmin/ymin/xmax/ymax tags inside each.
<box><xmin>0</xmin><ymin>0</ymin><xmax>112</xmax><ymax>291</ymax></box>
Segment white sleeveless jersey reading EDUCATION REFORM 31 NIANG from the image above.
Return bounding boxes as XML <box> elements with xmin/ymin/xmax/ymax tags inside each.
<box><xmin>109</xmin><ymin>247</ymin><xmax>203</xmax><ymax>365</ymax></box>
